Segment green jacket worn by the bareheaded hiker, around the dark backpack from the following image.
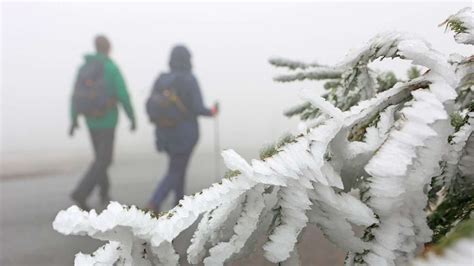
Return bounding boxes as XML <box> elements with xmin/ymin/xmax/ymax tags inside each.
<box><xmin>70</xmin><ymin>53</ymin><xmax>135</xmax><ymax>129</ymax></box>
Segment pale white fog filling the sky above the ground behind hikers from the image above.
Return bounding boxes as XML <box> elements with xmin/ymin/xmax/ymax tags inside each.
<box><xmin>1</xmin><ymin>1</ymin><xmax>471</xmax><ymax>176</ymax></box>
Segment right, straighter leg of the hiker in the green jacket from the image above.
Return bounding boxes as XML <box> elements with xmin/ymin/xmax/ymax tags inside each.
<box><xmin>97</xmin><ymin>128</ymin><xmax>115</xmax><ymax>203</ymax></box>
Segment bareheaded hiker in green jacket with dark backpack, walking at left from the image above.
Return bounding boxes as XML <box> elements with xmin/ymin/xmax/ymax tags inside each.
<box><xmin>69</xmin><ymin>36</ymin><xmax>136</xmax><ymax>210</ymax></box>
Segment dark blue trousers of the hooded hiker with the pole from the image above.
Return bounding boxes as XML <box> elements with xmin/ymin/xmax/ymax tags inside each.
<box><xmin>151</xmin><ymin>152</ymin><xmax>191</xmax><ymax>208</ymax></box>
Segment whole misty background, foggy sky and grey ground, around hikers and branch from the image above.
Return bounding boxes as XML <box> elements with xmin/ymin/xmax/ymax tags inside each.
<box><xmin>0</xmin><ymin>1</ymin><xmax>472</xmax><ymax>266</ymax></box>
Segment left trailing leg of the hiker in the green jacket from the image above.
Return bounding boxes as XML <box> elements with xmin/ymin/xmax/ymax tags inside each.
<box><xmin>71</xmin><ymin>129</ymin><xmax>99</xmax><ymax>209</ymax></box>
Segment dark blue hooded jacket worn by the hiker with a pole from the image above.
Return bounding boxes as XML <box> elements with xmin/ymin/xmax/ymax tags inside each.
<box><xmin>152</xmin><ymin>46</ymin><xmax>212</xmax><ymax>154</ymax></box>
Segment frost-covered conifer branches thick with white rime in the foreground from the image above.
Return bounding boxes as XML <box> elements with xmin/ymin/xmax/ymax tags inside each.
<box><xmin>53</xmin><ymin>8</ymin><xmax>474</xmax><ymax>265</ymax></box>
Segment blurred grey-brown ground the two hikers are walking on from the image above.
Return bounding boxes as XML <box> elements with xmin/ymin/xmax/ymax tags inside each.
<box><xmin>0</xmin><ymin>154</ymin><xmax>344</xmax><ymax>266</ymax></box>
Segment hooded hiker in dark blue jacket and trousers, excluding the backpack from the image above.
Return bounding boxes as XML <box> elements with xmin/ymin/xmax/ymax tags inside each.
<box><xmin>147</xmin><ymin>45</ymin><xmax>218</xmax><ymax>211</ymax></box>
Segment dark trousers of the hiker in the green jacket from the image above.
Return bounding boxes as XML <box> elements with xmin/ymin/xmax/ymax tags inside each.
<box><xmin>72</xmin><ymin>128</ymin><xmax>115</xmax><ymax>200</ymax></box>
